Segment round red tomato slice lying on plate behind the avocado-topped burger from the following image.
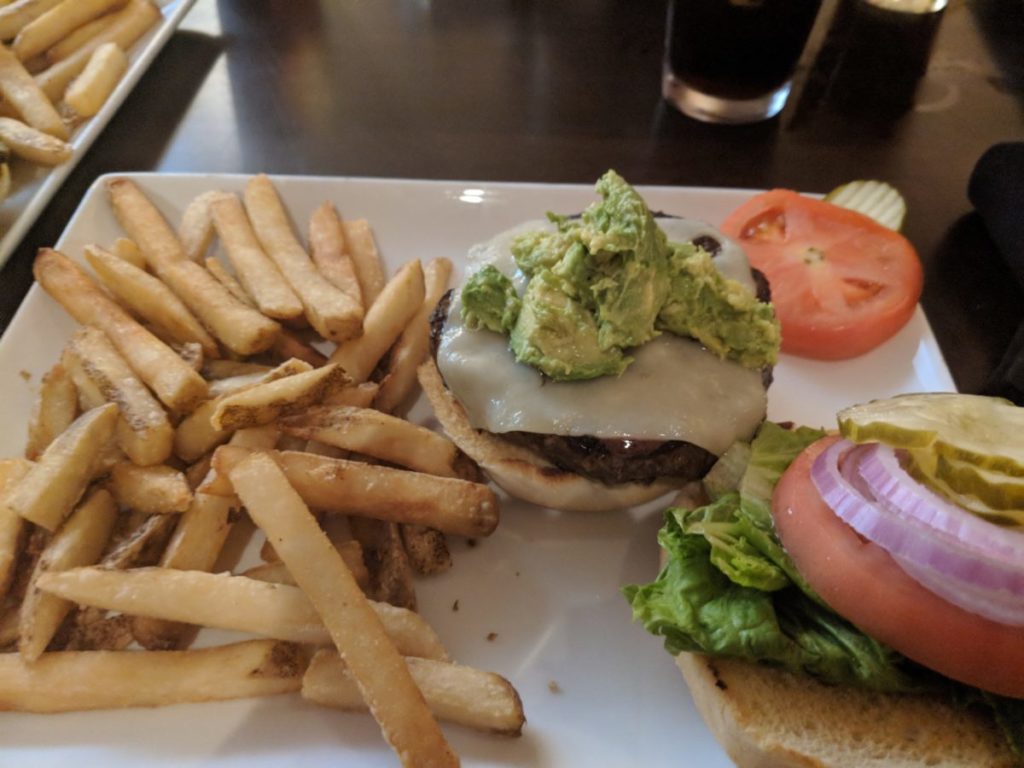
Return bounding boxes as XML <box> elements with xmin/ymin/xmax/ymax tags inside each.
<box><xmin>722</xmin><ymin>189</ymin><xmax>924</xmax><ymax>360</ymax></box>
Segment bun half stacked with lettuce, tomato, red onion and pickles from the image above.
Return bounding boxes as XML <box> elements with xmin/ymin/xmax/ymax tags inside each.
<box><xmin>625</xmin><ymin>394</ymin><xmax>1024</xmax><ymax>768</ymax></box>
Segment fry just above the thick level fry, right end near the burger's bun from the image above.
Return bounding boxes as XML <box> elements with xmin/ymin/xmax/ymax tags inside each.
<box><xmin>278</xmin><ymin>406</ymin><xmax>459</xmax><ymax>477</ymax></box>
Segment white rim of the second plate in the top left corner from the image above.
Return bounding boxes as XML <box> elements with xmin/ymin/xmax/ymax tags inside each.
<box><xmin>0</xmin><ymin>0</ymin><xmax>196</xmax><ymax>266</ymax></box>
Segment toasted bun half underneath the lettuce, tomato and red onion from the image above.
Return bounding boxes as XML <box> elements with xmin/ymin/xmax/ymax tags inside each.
<box><xmin>676</xmin><ymin>653</ymin><xmax>1020</xmax><ymax>768</ymax></box>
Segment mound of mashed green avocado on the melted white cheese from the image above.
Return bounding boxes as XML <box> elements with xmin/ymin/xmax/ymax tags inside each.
<box><xmin>462</xmin><ymin>171</ymin><xmax>779</xmax><ymax>380</ymax></box>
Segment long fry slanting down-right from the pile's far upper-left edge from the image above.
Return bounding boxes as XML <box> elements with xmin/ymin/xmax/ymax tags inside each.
<box><xmin>33</xmin><ymin>248</ymin><xmax>207</xmax><ymax>412</ymax></box>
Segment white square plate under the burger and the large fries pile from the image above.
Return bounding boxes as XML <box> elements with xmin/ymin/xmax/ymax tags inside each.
<box><xmin>0</xmin><ymin>174</ymin><xmax>953</xmax><ymax>768</ymax></box>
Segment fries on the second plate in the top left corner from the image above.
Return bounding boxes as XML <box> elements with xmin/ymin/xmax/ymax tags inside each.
<box><xmin>0</xmin><ymin>0</ymin><xmax>161</xmax><ymax>199</ymax></box>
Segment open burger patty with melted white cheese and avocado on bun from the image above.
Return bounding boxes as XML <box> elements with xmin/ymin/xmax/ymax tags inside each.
<box><xmin>420</xmin><ymin>171</ymin><xmax>779</xmax><ymax>511</ymax></box>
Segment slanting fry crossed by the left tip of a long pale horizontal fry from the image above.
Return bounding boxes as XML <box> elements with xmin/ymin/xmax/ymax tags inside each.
<box><xmin>18</xmin><ymin>488</ymin><xmax>118</xmax><ymax>662</ymax></box>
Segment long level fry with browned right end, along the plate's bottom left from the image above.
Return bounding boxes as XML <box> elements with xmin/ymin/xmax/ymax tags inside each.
<box><xmin>0</xmin><ymin>640</ymin><xmax>306</xmax><ymax>713</ymax></box>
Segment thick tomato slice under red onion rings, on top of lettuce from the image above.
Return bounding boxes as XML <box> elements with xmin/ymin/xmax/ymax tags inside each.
<box><xmin>772</xmin><ymin>437</ymin><xmax>1024</xmax><ymax>698</ymax></box>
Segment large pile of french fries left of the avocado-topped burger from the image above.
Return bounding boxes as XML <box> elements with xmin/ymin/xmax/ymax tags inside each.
<box><xmin>0</xmin><ymin>175</ymin><xmax>524</xmax><ymax>766</ymax></box>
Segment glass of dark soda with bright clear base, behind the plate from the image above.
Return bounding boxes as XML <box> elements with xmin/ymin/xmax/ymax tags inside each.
<box><xmin>663</xmin><ymin>0</ymin><xmax>821</xmax><ymax>123</ymax></box>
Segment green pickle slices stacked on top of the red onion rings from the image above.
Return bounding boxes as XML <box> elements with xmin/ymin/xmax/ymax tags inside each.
<box><xmin>839</xmin><ymin>392</ymin><xmax>1024</xmax><ymax>481</ymax></box>
